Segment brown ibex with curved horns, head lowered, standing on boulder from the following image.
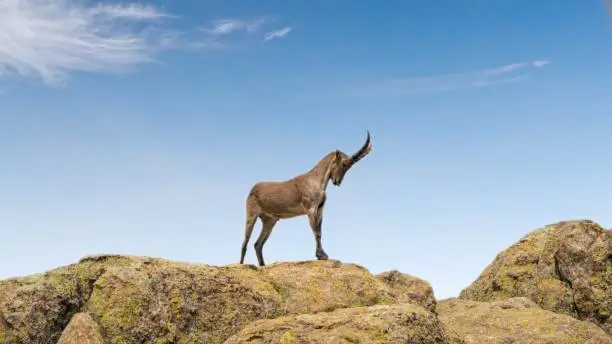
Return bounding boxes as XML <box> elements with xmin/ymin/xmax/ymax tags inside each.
<box><xmin>240</xmin><ymin>131</ymin><xmax>372</xmax><ymax>266</ymax></box>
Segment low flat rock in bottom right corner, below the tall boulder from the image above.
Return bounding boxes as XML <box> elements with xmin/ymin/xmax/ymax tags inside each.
<box><xmin>437</xmin><ymin>298</ymin><xmax>612</xmax><ymax>344</ymax></box>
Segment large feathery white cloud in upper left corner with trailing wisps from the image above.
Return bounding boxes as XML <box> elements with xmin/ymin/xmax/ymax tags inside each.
<box><xmin>0</xmin><ymin>0</ymin><xmax>292</xmax><ymax>86</ymax></box>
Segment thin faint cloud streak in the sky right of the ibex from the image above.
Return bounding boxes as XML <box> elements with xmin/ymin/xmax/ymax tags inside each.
<box><xmin>354</xmin><ymin>60</ymin><xmax>551</xmax><ymax>95</ymax></box>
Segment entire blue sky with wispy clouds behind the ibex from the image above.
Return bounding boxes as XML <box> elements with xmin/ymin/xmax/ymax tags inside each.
<box><xmin>0</xmin><ymin>0</ymin><xmax>612</xmax><ymax>298</ymax></box>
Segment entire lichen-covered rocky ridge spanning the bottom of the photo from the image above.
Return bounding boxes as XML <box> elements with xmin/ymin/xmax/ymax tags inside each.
<box><xmin>0</xmin><ymin>221</ymin><xmax>612</xmax><ymax>344</ymax></box>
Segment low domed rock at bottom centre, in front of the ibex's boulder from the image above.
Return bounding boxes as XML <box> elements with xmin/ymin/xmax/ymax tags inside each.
<box><xmin>225</xmin><ymin>304</ymin><xmax>463</xmax><ymax>344</ymax></box>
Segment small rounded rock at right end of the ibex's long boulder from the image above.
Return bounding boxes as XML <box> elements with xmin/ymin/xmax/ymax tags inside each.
<box><xmin>376</xmin><ymin>270</ymin><xmax>436</xmax><ymax>313</ymax></box>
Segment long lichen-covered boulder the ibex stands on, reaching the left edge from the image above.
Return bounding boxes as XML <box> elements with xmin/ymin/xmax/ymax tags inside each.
<box><xmin>0</xmin><ymin>255</ymin><xmax>436</xmax><ymax>344</ymax></box>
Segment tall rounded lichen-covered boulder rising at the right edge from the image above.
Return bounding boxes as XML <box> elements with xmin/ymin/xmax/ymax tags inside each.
<box><xmin>459</xmin><ymin>220</ymin><xmax>612</xmax><ymax>335</ymax></box>
